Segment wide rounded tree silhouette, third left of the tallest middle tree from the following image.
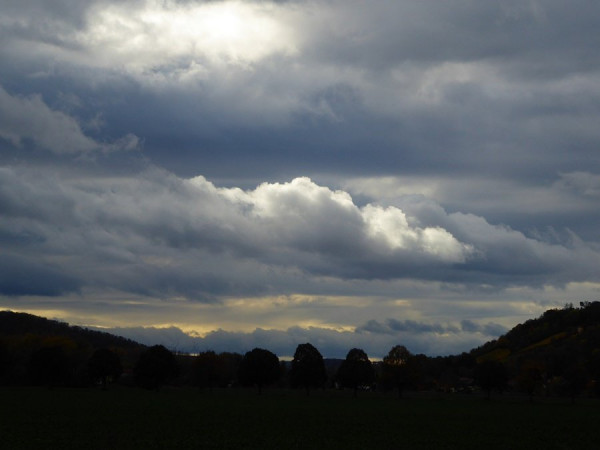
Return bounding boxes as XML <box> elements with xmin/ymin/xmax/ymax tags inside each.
<box><xmin>133</xmin><ymin>345</ymin><xmax>179</xmax><ymax>389</ymax></box>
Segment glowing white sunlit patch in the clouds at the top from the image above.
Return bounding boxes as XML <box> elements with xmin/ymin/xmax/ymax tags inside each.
<box><xmin>78</xmin><ymin>0</ymin><xmax>294</xmax><ymax>73</ymax></box>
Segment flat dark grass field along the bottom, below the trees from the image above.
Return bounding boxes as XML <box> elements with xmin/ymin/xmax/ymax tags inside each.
<box><xmin>0</xmin><ymin>388</ymin><xmax>600</xmax><ymax>449</ymax></box>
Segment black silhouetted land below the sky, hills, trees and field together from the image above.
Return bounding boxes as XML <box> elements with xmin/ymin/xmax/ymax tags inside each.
<box><xmin>0</xmin><ymin>302</ymin><xmax>600</xmax><ymax>448</ymax></box>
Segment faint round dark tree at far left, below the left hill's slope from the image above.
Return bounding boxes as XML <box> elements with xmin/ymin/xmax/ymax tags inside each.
<box><xmin>29</xmin><ymin>346</ymin><xmax>70</xmax><ymax>388</ymax></box>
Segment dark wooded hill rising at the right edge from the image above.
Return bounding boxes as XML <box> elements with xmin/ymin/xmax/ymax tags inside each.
<box><xmin>470</xmin><ymin>302</ymin><xmax>600</xmax><ymax>398</ymax></box>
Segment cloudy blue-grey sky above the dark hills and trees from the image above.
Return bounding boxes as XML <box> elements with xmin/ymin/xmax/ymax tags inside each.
<box><xmin>0</xmin><ymin>0</ymin><xmax>600</xmax><ymax>358</ymax></box>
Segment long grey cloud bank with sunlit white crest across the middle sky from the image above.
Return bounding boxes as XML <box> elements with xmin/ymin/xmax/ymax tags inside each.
<box><xmin>0</xmin><ymin>168</ymin><xmax>599</xmax><ymax>298</ymax></box>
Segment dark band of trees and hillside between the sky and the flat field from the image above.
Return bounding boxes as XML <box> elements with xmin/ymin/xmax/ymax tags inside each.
<box><xmin>0</xmin><ymin>302</ymin><xmax>600</xmax><ymax>398</ymax></box>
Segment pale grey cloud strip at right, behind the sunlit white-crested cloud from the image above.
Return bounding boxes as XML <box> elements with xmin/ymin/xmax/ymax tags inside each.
<box><xmin>346</xmin><ymin>172</ymin><xmax>600</xmax><ymax>245</ymax></box>
